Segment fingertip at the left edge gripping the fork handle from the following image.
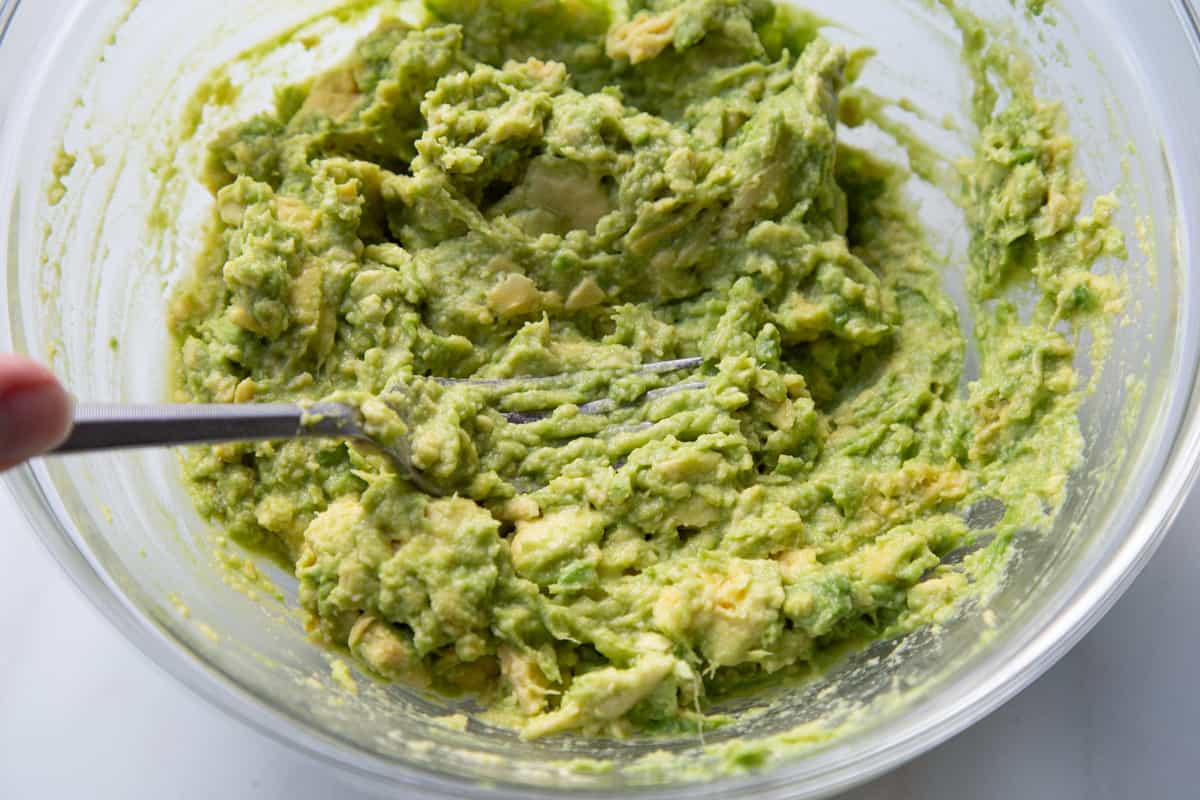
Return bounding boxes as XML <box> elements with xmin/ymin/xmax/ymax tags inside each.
<box><xmin>0</xmin><ymin>355</ymin><xmax>73</xmax><ymax>470</ymax></box>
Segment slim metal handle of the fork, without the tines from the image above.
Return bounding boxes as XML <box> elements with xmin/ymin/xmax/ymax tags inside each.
<box><xmin>52</xmin><ymin>403</ymin><xmax>355</xmax><ymax>453</ymax></box>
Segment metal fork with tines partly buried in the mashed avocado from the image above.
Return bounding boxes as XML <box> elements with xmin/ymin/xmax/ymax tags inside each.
<box><xmin>53</xmin><ymin>357</ymin><xmax>704</xmax><ymax>497</ymax></box>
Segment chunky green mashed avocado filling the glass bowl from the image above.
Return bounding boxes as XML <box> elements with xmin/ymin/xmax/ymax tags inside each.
<box><xmin>172</xmin><ymin>0</ymin><xmax>1123</xmax><ymax>736</ymax></box>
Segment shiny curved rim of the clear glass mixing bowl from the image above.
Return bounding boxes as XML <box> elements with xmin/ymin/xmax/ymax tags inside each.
<box><xmin>7</xmin><ymin>0</ymin><xmax>1200</xmax><ymax>799</ymax></box>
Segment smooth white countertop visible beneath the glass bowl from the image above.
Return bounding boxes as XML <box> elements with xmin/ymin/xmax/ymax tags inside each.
<box><xmin>0</xmin><ymin>489</ymin><xmax>1200</xmax><ymax>800</ymax></box>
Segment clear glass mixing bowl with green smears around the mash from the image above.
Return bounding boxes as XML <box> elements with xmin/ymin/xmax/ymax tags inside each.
<box><xmin>0</xmin><ymin>0</ymin><xmax>1200</xmax><ymax>799</ymax></box>
